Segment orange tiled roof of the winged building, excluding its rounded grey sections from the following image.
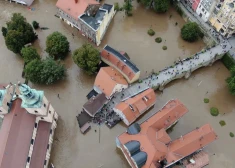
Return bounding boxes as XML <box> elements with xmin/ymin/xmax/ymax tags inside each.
<box><xmin>117</xmin><ymin>100</ymin><xmax>216</xmax><ymax>168</ymax></box>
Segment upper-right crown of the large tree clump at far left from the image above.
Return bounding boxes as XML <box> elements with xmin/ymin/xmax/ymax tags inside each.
<box><xmin>7</xmin><ymin>13</ymin><xmax>37</xmax><ymax>44</ymax></box>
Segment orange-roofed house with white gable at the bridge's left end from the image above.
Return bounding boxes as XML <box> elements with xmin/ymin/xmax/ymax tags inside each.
<box><xmin>93</xmin><ymin>66</ymin><xmax>128</xmax><ymax>99</ymax></box>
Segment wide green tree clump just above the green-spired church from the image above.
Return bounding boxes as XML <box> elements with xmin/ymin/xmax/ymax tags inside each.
<box><xmin>24</xmin><ymin>57</ymin><xmax>66</xmax><ymax>85</ymax></box>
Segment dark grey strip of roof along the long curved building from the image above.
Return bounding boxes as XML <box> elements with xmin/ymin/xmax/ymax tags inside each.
<box><xmin>104</xmin><ymin>45</ymin><xmax>140</xmax><ymax>73</ymax></box>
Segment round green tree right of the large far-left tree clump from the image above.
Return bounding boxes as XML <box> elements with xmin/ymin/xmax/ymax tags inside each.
<box><xmin>46</xmin><ymin>32</ymin><xmax>69</xmax><ymax>59</ymax></box>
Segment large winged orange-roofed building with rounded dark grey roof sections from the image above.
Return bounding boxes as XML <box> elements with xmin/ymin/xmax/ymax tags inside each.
<box><xmin>116</xmin><ymin>100</ymin><xmax>217</xmax><ymax>168</ymax></box>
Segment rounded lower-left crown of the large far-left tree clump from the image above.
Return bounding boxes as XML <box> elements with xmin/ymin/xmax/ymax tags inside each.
<box><xmin>5</xmin><ymin>30</ymin><xmax>25</xmax><ymax>54</ymax></box>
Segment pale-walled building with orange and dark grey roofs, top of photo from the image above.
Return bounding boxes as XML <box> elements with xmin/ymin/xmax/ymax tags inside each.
<box><xmin>56</xmin><ymin>0</ymin><xmax>116</xmax><ymax>46</ymax></box>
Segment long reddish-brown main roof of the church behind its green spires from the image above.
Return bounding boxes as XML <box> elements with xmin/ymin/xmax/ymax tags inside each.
<box><xmin>0</xmin><ymin>99</ymin><xmax>36</xmax><ymax>168</ymax></box>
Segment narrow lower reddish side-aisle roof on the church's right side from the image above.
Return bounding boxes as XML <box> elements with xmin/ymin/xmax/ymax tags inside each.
<box><xmin>30</xmin><ymin>121</ymin><xmax>51</xmax><ymax>168</ymax></box>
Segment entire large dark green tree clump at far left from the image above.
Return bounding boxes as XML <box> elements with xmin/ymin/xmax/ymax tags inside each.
<box><xmin>2</xmin><ymin>13</ymin><xmax>37</xmax><ymax>53</ymax></box>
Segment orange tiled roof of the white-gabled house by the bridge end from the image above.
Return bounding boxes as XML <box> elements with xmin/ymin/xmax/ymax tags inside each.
<box><xmin>94</xmin><ymin>67</ymin><xmax>128</xmax><ymax>97</ymax></box>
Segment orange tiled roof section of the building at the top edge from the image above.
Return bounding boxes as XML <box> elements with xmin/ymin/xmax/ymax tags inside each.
<box><xmin>56</xmin><ymin>0</ymin><xmax>99</xmax><ymax>20</ymax></box>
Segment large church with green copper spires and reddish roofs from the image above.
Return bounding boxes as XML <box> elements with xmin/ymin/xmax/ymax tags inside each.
<box><xmin>0</xmin><ymin>83</ymin><xmax>58</xmax><ymax>168</ymax></box>
